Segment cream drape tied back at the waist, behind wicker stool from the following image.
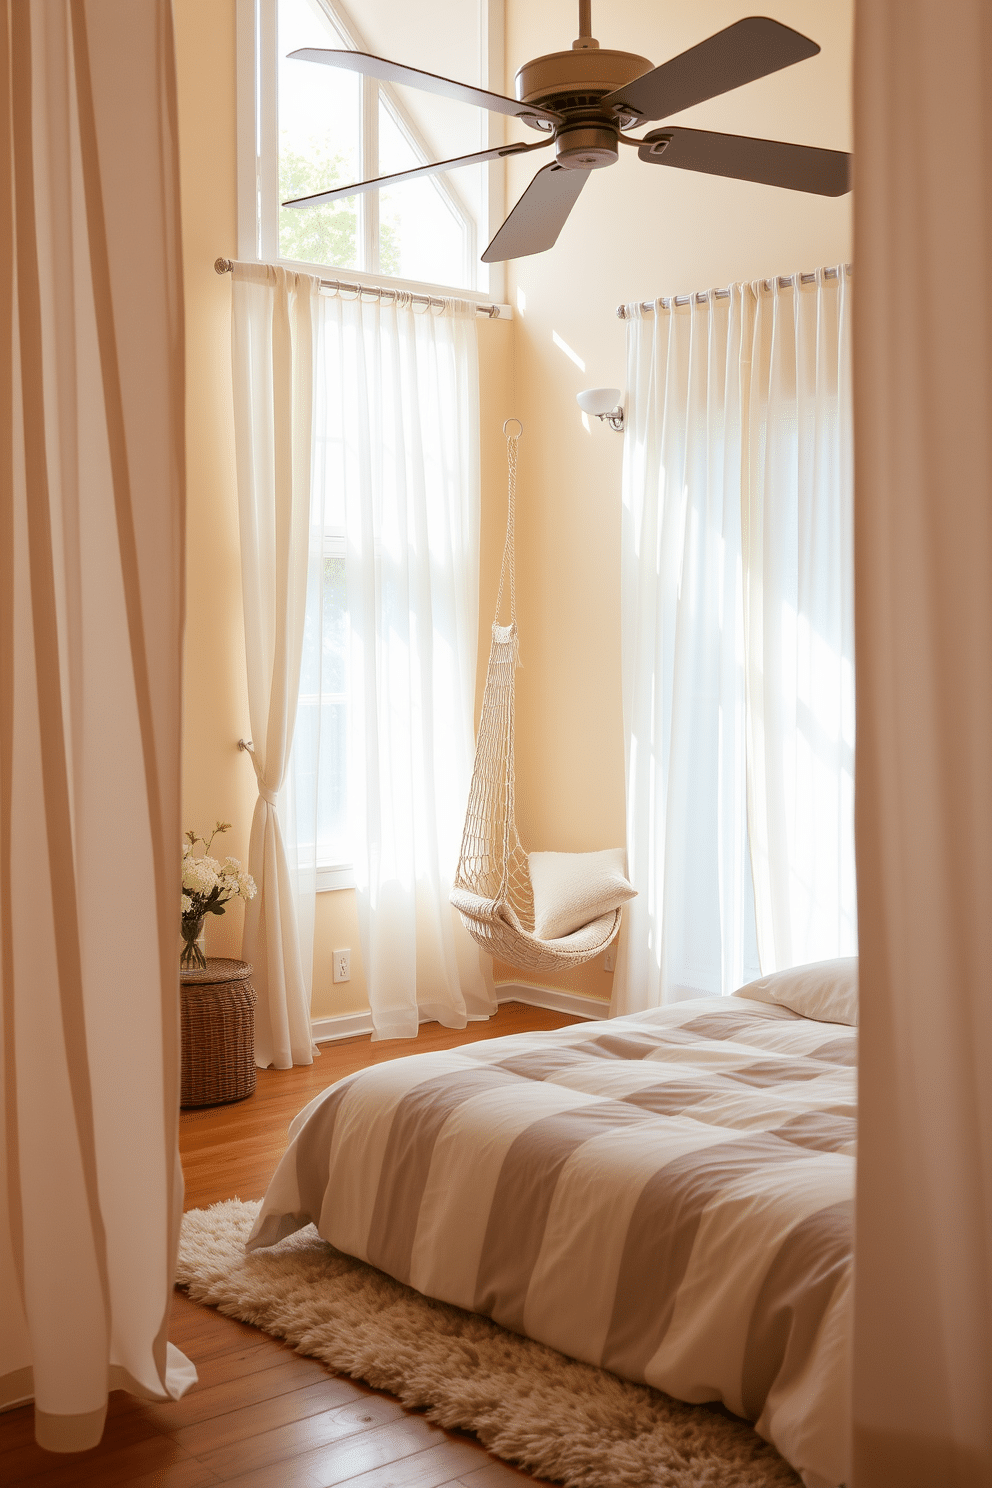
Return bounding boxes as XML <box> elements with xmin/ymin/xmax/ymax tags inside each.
<box><xmin>232</xmin><ymin>263</ymin><xmax>320</xmax><ymax>1070</ymax></box>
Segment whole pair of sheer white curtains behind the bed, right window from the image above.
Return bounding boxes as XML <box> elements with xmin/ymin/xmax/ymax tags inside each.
<box><xmin>613</xmin><ymin>268</ymin><xmax>857</xmax><ymax>1012</ymax></box>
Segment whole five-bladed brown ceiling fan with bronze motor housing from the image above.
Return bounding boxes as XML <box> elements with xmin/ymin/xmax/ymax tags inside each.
<box><xmin>283</xmin><ymin>0</ymin><xmax>851</xmax><ymax>263</ymax></box>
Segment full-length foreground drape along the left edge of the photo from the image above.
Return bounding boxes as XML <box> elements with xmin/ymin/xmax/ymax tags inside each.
<box><xmin>0</xmin><ymin>0</ymin><xmax>196</xmax><ymax>1446</ymax></box>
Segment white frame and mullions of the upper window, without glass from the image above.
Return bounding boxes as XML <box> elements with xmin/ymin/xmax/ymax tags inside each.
<box><xmin>236</xmin><ymin>0</ymin><xmax>506</xmax><ymax>304</ymax></box>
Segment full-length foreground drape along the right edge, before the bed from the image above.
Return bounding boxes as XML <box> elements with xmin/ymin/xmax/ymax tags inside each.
<box><xmin>854</xmin><ymin>0</ymin><xmax>992</xmax><ymax>1488</ymax></box>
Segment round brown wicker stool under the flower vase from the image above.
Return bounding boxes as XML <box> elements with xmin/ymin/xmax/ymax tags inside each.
<box><xmin>180</xmin><ymin>955</ymin><xmax>254</xmax><ymax>1106</ymax></box>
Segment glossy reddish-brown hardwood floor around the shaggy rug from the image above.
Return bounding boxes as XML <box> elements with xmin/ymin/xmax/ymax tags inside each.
<box><xmin>0</xmin><ymin>1003</ymin><xmax>579</xmax><ymax>1488</ymax></box>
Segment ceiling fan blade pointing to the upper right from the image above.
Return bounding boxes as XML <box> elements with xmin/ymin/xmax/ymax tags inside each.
<box><xmin>599</xmin><ymin>15</ymin><xmax>819</xmax><ymax>119</ymax></box>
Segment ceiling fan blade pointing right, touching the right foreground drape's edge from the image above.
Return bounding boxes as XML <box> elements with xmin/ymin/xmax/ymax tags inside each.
<box><xmin>637</xmin><ymin>125</ymin><xmax>851</xmax><ymax>196</ymax></box>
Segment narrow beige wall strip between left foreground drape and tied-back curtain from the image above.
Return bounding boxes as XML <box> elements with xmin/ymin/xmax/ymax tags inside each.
<box><xmin>174</xmin><ymin>0</ymin><xmax>254</xmax><ymax>955</ymax></box>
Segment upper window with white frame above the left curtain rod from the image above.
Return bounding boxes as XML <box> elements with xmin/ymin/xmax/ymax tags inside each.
<box><xmin>238</xmin><ymin>0</ymin><xmax>504</xmax><ymax>295</ymax></box>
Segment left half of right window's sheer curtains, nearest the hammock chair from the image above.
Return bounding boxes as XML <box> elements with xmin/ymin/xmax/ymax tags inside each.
<box><xmin>613</xmin><ymin>286</ymin><xmax>754</xmax><ymax>1013</ymax></box>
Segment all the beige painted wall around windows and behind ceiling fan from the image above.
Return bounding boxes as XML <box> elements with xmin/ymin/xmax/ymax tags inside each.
<box><xmin>174</xmin><ymin>0</ymin><xmax>852</xmax><ymax>1016</ymax></box>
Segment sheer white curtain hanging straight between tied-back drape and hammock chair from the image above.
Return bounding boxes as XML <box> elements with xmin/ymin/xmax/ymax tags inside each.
<box><xmin>306</xmin><ymin>296</ymin><xmax>495</xmax><ymax>1039</ymax></box>
